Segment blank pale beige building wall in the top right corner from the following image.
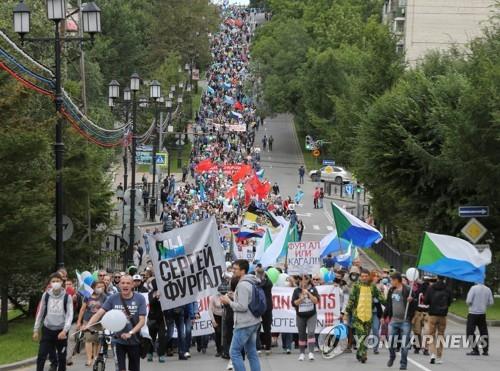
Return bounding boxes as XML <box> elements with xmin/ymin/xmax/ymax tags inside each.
<box><xmin>405</xmin><ymin>0</ymin><xmax>495</xmax><ymax>65</ymax></box>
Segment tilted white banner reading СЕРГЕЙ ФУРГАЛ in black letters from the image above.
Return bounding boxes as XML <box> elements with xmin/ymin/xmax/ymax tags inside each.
<box><xmin>149</xmin><ymin>217</ymin><xmax>225</xmax><ymax>310</ymax></box>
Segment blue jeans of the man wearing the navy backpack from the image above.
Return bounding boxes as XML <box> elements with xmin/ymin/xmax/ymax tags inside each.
<box><xmin>229</xmin><ymin>324</ymin><xmax>260</xmax><ymax>371</ymax></box>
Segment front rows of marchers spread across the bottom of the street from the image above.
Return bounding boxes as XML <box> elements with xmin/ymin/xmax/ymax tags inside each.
<box><xmin>33</xmin><ymin>259</ymin><xmax>493</xmax><ymax>371</ymax></box>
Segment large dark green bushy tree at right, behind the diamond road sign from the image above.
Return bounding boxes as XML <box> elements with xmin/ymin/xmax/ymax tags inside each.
<box><xmin>355</xmin><ymin>30</ymin><xmax>500</xmax><ymax>269</ymax></box>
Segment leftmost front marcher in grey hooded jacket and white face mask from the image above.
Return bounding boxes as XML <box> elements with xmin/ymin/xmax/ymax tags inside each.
<box><xmin>33</xmin><ymin>273</ymin><xmax>73</xmax><ymax>371</ymax></box>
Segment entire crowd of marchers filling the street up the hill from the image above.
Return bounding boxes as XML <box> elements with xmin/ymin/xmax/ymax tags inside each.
<box><xmin>33</xmin><ymin>7</ymin><xmax>493</xmax><ymax>371</ymax></box>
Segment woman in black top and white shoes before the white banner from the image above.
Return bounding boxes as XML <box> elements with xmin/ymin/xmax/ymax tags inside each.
<box><xmin>292</xmin><ymin>275</ymin><xmax>319</xmax><ymax>361</ymax></box>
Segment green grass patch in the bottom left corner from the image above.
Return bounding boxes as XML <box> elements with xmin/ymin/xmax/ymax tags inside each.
<box><xmin>0</xmin><ymin>318</ymin><xmax>38</xmax><ymax>365</ymax></box>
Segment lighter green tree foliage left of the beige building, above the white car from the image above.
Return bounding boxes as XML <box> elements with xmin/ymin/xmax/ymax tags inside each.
<box><xmin>252</xmin><ymin>0</ymin><xmax>403</xmax><ymax>166</ymax></box>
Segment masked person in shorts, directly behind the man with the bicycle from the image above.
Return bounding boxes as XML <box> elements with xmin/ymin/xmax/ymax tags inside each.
<box><xmin>76</xmin><ymin>281</ymin><xmax>107</xmax><ymax>366</ymax></box>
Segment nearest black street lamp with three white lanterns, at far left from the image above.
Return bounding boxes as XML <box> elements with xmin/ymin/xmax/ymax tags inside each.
<box><xmin>13</xmin><ymin>0</ymin><xmax>101</xmax><ymax>268</ymax></box>
